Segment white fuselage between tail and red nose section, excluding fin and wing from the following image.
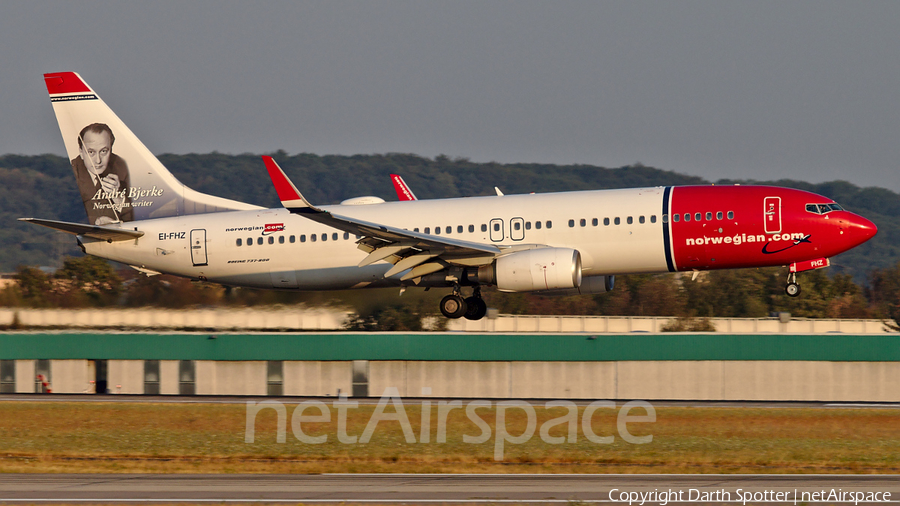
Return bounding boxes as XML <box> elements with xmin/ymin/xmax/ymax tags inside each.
<box><xmin>82</xmin><ymin>187</ymin><xmax>668</xmax><ymax>290</ymax></box>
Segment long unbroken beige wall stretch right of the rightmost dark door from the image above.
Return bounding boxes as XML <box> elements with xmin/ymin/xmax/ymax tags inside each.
<box><xmin>369</xmin><ymin>360</ymin><xmax>900</xmax><ymax>402</ymax></box>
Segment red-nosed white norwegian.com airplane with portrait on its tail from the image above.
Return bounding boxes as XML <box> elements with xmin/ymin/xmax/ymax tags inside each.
<box><xmin>22</xmin><ymin>72</ymin><xmax>877</xmax><ymax>320</ymax></box>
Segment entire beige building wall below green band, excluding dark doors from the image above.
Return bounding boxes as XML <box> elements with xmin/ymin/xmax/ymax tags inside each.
<box><xmin>16</xmin><ymin>360</ymin><xmax>900</xmax><ymax>402</ymax></box>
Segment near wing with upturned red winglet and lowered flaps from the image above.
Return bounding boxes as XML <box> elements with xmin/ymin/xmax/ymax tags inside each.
<box><xmin>263</xmin><ymin>156</ymin><xmax>506</xmax><ymax>280</ymax></box>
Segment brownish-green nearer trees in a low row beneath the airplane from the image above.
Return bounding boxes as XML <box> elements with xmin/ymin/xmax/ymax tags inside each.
<box><xmin>0</xmin><ymin>256</ymin><xmax>900</xmax><ymax>330</ymax></box>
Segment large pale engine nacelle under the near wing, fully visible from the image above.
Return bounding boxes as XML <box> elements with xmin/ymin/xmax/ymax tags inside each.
<box><xmin>478</xmin><ymin>248</ymin><xmax>581</xmax><ymax>292</ymax></box>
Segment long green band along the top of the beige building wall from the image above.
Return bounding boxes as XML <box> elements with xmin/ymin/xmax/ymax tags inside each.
<box><xmin>0</xmin><ymin>332</ymin><xmax>900</xmax><ymax>362</ymax></box>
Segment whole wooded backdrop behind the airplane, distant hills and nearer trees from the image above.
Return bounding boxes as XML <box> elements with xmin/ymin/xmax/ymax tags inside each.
<box><xmin>0</xmin><ymin>151</ymin><xmax>900</xmax><ymax>330</ymax></box>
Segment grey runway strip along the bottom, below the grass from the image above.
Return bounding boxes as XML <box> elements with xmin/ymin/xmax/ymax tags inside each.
<box><xmin>0</xmin><ymin>474</ymin><xmax>900</xmax><ymax>504</ymax></box>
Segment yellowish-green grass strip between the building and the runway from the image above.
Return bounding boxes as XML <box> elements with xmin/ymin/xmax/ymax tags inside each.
<box><xmin>0</xmin><ymin>401</ymin><xmax>900</xmax><ymax>473</ymax></box>
